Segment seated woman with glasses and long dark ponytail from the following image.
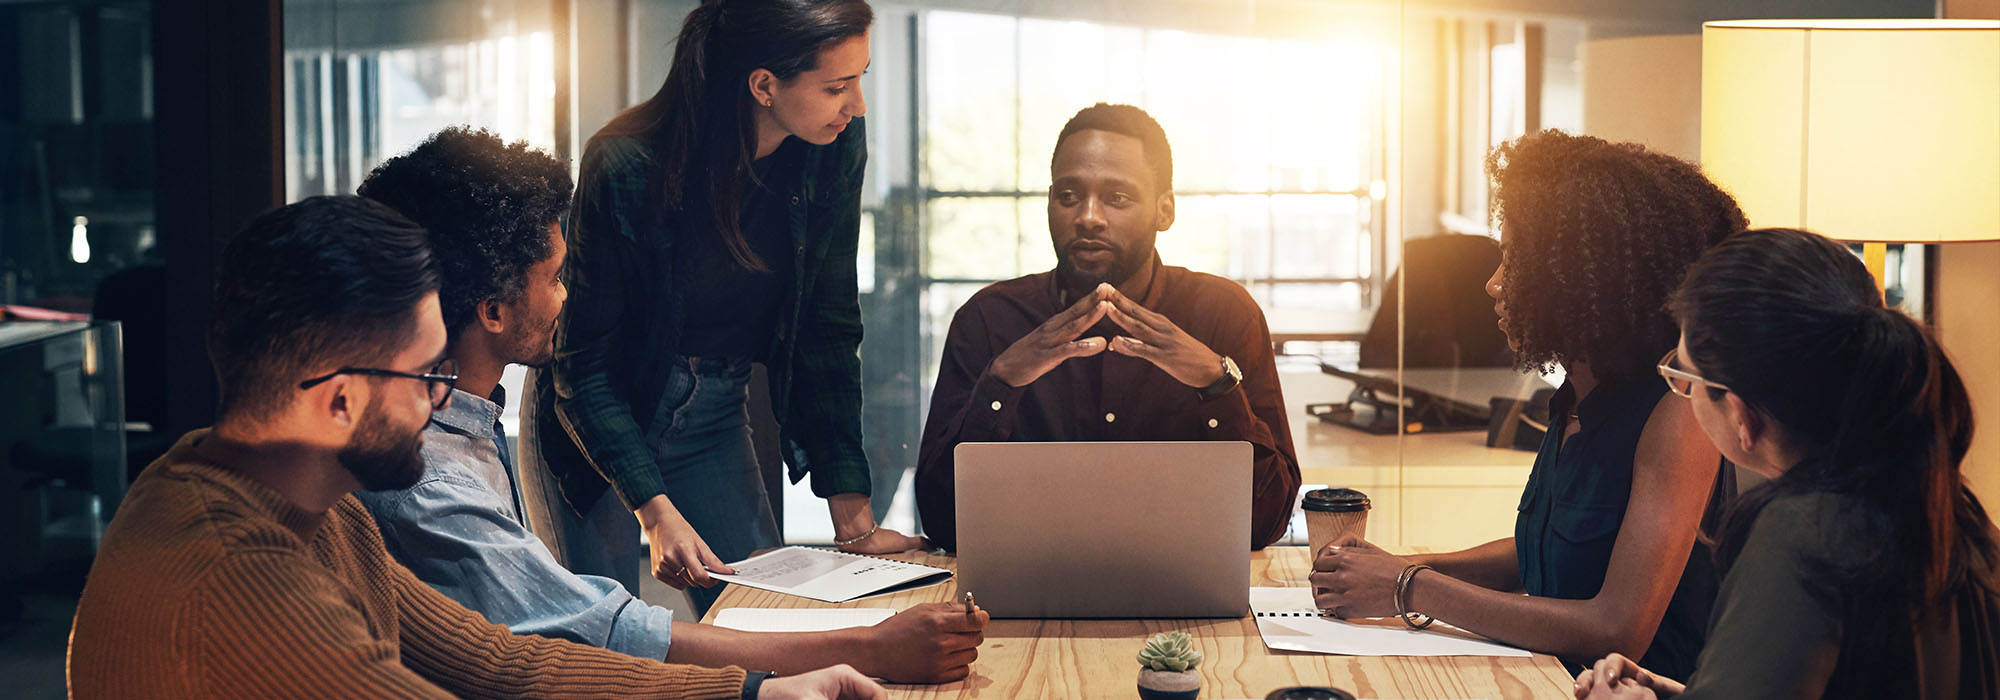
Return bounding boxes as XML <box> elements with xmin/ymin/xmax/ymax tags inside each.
<box><xmin>1576</xmin><ymin>228</ymin><xmax>2000</xmax><ymax>698</ymax></box>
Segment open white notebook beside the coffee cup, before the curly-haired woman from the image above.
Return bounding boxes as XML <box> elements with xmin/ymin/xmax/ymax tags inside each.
<box><xmin>1250</xmin><ymin>588</ymin><xmax>1534</xmax><ymax>656</ymax></box>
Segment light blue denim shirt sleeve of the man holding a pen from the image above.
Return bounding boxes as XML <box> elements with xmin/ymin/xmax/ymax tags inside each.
<box><xmin>362</xmin><ymin>474</ymin><xmax>674</xmax><ymax>660</ymax></box>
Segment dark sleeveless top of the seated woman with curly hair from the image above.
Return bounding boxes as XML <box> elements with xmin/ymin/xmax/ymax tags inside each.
<box><xmin>1514</xmin><ymin>374</ymin><xmax>1736</xmax><ymax>680</ymax></box>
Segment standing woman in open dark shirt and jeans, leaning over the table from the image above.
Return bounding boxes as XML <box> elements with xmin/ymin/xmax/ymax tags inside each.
<box><xmin>528</xmin><ymin>0</ymin><xmax>922</xmax><ymax>614</ymax></box>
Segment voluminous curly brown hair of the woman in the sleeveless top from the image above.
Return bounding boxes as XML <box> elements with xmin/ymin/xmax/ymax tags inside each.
<box><xmin>1486</xmin><ymin>130</ymin><xmax>1746</xmax><ymax>380</ymax></box>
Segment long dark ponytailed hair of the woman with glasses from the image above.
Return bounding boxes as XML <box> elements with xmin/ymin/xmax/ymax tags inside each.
<box><xmin>1672</xmin><ymin>228</ymin><xmax>1994</xmax><ymax>638</ymax></box>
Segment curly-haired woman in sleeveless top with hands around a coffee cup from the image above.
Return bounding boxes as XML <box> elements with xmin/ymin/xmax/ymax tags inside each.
<box><xmin>1312</xmin><ymin>132</ymin><xmax>1744</xmax><ymax>678</ymax></box>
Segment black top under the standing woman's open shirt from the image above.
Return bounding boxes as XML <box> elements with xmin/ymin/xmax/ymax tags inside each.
<box><xmin>680</xmin><ymin>138</ymin><xmax>800</xmax><ymax>360</ymax></box>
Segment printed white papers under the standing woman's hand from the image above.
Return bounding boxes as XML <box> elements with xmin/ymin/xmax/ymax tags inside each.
<box><xmin>710</xmin><ymin>546</ymin><xmax>952</xmax><ymax>602</ymax></box>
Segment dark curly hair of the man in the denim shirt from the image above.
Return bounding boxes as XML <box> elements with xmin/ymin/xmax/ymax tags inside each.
<box><xmin>358</xmin><ymin>126</ymin><xmax>572</xmax><ymax>338</ymax></box>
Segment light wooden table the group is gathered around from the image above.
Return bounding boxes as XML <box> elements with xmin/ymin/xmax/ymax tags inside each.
<box><xmin>702</xmin><ymin>546</ymin><xmax>1572</xmax><ymax>700</ymax></box>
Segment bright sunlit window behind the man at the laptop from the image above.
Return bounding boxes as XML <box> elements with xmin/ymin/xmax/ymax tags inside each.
<box><xmin>918</xmin><ymin>12</ymin><xmax>1394</xmax><ymax>394</ymax></box>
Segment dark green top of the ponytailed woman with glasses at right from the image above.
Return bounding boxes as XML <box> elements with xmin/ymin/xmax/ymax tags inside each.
<box><xmin>1680</xmin><ymin>494</ymin><xmax>2000</xmax><ymax>700</ymax></box>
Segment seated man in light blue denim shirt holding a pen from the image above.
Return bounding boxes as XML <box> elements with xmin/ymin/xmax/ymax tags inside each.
<box><xmin>358</xmin><ymin>128</ymin><xmax>986</xmax><ymax>682</ymax></box>
